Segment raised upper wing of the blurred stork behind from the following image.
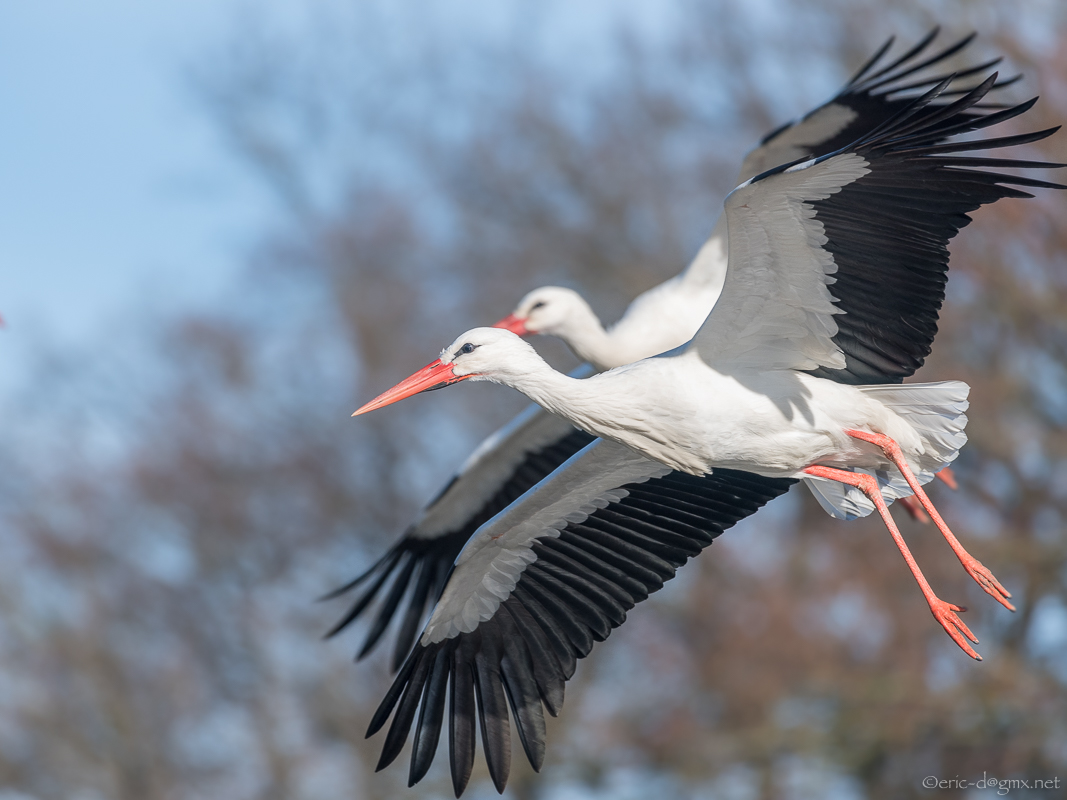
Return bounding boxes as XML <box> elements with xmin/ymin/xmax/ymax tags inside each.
<box><xmin>737</xmin><ymin>28</ymin><xmax>1019</xmax><ymax>183</ymax></box>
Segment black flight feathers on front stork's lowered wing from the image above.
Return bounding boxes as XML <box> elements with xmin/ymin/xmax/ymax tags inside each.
<box><xmin>367</xmin><ymin>469</ymin><xmax>796</xmax><ymax>797</ymax></box>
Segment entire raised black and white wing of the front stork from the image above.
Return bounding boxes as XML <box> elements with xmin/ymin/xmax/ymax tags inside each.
<box><xmin>690</xmin><ymin>74</ymin><xmax>1065</xmax><ymax>384</ymax></box>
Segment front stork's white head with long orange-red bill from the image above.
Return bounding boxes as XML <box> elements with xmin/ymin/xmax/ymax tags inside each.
<box><xmin>352</xmin><ymin>327</ymin><xmax>544</xmax><ymax>417</ymax></box>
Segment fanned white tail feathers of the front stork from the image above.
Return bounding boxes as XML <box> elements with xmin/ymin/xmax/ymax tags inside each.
<box><xmin>805</xmin><ymin>381</ymin><xmax>971</xmax><ymax>519</ymax></box>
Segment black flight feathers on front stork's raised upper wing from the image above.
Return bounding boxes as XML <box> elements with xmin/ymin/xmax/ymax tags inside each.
<box><xmin>752</xmin><ymin>73</ymin><xmax>1065</xmax><ymax>384</ymax></box>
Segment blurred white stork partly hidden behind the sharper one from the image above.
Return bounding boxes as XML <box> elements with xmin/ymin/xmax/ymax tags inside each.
<box><xmin>327</xmin><ymin>28</ymin><xmax>1016</xmax><ymax>669</ymax></box>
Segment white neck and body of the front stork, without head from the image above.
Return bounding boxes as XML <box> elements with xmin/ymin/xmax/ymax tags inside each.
<box><xmin>495</xmin><ymin>348</ymin><xmax>966</xmax><ymax>478</ymax></box>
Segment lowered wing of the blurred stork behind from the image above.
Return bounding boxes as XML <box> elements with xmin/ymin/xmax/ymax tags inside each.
<box><xmin>325</xmin><ymin>405</ymin><xmax>593</xmax><ymax>670</ymax></box>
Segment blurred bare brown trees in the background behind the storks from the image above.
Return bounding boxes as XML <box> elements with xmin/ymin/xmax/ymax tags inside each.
<box><xmin>0</xmin><ymin>0</ymin><xmax>1067</xmax><ymax>800</ymax></box>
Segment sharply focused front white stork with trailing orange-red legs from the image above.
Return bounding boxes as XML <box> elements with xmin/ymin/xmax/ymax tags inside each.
<box><xmin>356</xmin><ymin>75</ymin><xmax>1067</xmax><ymax>796</ymax></box>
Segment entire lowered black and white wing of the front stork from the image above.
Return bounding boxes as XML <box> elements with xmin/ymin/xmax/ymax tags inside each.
<box><xmin>367</xmin><ymin>441</ymin><xmax>796</xmax><ymax>797</ymax></box>
